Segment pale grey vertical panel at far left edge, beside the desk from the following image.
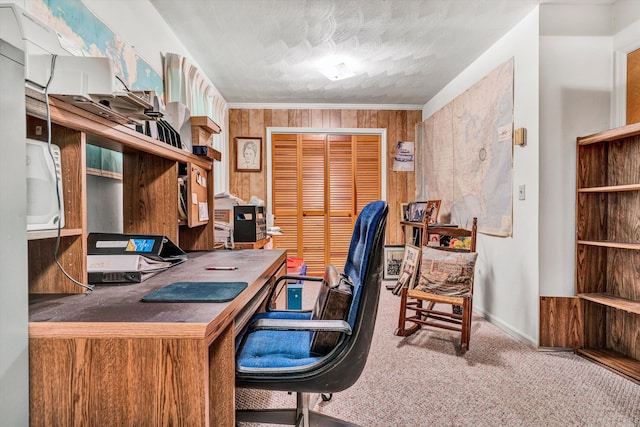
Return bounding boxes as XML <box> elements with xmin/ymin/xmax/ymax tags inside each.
<box><xmin>0</xmin><ymin>31</ymin><xmax>29</xmax><ymax>426</ymax></box>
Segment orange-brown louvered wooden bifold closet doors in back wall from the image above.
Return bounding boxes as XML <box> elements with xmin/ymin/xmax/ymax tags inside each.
<box><xmin>271</xmin><ymin>134</ymin><xmax>382</xmax><ymax>275</ymax></box>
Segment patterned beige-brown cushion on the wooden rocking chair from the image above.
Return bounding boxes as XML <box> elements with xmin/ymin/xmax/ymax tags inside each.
<box><xmin>415</xmin><ymin>246</ymin><xmax>478</xmax><ymax>297</ymax></box>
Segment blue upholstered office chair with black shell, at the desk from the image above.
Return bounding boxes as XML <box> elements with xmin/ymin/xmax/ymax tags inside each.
<box><xmin>236</xmin><ymin>201</ymin><xmax>388</xmax><ymax>426</ymax></box>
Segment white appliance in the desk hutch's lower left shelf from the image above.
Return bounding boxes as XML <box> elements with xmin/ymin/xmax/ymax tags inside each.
<box><xmin>27</xmin><ymin>139</ymin><xmax>64</xmax><ymax>231</ymax></box>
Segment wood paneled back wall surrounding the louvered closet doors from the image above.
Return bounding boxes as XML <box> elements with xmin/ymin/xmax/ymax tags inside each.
<box><xmin>229</xmin><ymin>109</ymin><xmax>422</xmax><ymax>244</ymax></box>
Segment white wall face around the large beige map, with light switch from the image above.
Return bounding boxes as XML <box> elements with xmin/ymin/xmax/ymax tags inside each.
<box><xmin>422</xmin><ymin>8</ymin><xmax>539</xmax><ymax>344</ymax></box>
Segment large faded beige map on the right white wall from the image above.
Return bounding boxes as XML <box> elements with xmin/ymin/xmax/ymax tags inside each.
<box><xmin>421</xmin><ymin>58</ymin><xmax>513</xmax><ymax>236</ymax></box>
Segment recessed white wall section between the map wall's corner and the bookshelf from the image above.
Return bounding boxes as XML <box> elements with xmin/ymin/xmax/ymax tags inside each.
<box><xmin>539</xmin><ymin>5</ymin><xmax>613</xmax><ymax>302</ymax></box>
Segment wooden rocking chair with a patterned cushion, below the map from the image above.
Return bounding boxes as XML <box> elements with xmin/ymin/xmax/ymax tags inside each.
<box><xmin>395</xmin><ymin>218</ymin><xmax>478</xmax><ymax>351</ymax></box>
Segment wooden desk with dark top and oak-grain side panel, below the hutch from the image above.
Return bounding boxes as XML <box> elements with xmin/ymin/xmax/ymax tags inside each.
<box><xmin>29</xmin><ymin>250</ymin><xmax>286</xmax><ymax>426</ymax></box>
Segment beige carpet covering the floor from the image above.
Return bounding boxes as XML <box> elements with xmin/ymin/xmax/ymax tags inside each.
<box><xmin>236</xmin><ymin>285</ymin><xmax>640</xmax><ymax>427</ymax></box>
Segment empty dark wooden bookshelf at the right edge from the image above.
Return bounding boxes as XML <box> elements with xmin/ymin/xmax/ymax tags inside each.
<box><xmin>575</xmin><ymin>124</ymin><xmax>640</xmax><ymax>381</ymax></box>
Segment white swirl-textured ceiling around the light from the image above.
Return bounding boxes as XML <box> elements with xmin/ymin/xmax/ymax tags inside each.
<box><xmin>151</xmin><ymin>0</ymin><xmax>608</xmax><ymax>105</ymax></box>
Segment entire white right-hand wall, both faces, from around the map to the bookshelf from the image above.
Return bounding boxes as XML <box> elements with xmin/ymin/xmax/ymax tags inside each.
<box><xmin>423</xmin><ymin>2</ymin><xmax>640</xmax><ymax>345</ymax></box>
